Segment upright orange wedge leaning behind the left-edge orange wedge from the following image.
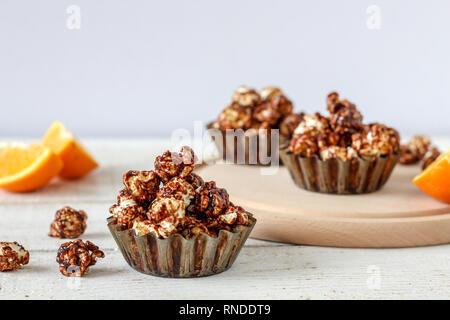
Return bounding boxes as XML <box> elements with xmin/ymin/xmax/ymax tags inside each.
<box><xmin>42</xmin><ymin>121</ymin><xmax>98</xmax><ymax>179</ymax></box>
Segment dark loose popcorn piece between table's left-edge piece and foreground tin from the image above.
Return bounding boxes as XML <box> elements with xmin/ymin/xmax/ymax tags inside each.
<box><xmin>56</xmin><ymin>239</ymin><xmax>105</xmax><ymax>277</ymax></box>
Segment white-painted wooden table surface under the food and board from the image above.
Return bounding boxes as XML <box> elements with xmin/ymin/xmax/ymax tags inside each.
<box><xmin>0</xmin><ymin>139</ymin><xmax>450</xmax><ymax>299</ymax></box>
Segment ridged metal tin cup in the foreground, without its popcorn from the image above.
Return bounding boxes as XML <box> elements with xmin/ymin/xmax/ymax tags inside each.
<box><xmin>107</xmin><ymin>217</ymin><xmax>256</xmax><ymax>278</ymax></box>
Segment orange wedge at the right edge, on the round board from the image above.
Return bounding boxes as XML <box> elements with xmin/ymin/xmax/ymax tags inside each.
<box><xmin>413</xmin><ymin>149</ymin><xmax>450</xmax><ymax>203</ymax></box>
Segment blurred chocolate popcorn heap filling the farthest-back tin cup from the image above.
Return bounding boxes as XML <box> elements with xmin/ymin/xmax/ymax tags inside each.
<box><xmin>213</xmin><ymin>86</ymin><xmax>302</xmax><ymax>136</ymax></box>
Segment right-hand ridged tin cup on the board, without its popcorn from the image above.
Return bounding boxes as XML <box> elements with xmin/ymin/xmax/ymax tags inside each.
<box><xmin>280</xmin><ymin>144</ymin><xmax>400</xmax><ymax>194</ymax></box>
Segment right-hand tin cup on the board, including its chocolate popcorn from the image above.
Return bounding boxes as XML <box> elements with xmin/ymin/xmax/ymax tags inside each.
<box><xmin>280</xmin><ymin>92</ymin><xmax>400</xmax><ymax>194</ymax></box>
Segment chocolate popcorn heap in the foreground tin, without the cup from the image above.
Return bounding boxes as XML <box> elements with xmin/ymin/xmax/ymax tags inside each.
<box><xmin>110</xmin><ymin>146</ymin><xmax>250</xmax><ymax>238</ymax></box>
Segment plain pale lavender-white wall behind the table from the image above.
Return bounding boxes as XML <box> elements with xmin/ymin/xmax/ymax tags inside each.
<box><xmin>0</xmin><ymin>0</ymin><xmax>450</xmax><ymax>137</ymax></box>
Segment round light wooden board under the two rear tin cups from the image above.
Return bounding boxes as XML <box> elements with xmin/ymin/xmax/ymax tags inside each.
<box><xmin>197</xmin><ymin>164</ymin><xmax>450</xmax><ymax>248</ymax></box>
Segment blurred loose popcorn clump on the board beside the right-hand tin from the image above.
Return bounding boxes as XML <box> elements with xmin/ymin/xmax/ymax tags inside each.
<box><xmin>399</xmin><ymin>135</ymin><xmax>441</xmax><ymax>169</ymax></box>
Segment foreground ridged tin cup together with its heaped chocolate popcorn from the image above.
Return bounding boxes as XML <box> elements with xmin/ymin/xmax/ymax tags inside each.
<box><xmin>108</xmin><ymin>146</ymin><xmax>256</xmax><ymax>278</ymax></box>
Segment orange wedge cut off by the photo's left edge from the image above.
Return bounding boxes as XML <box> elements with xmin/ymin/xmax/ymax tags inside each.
<box><xmin>0</xmin><ymin>143</ymin><xmax>63</xmax><ymax>192</ymax></box>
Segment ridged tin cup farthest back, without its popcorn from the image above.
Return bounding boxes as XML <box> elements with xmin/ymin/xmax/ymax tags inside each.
<box><xmin>206</xmin><ymin>122</ymin><xmax>285</xmax><ymax>165</ymax></box>
